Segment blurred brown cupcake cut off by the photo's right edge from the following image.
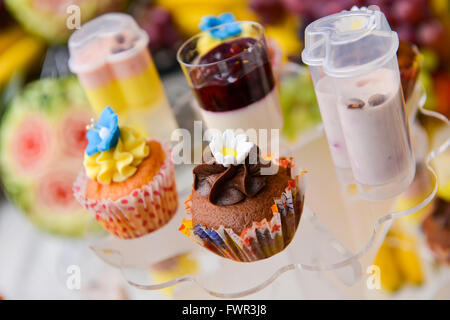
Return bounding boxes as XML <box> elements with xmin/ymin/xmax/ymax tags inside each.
<box><xmin>422</xmin><ymin>198</ymin><xmax>450</xmax><ymax>264</ymax></box>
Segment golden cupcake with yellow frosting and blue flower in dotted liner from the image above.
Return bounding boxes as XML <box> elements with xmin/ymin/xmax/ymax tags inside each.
<box><xmin>74</xmin><ymin>107</ymin><xmax>178</xmax><ymax>239</ymax></box>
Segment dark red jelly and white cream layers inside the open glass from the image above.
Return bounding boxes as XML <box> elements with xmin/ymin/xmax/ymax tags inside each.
<box><xmin>190</xmin><ymin>37</ymin><xmax>283</xmax><ymax>134</ymax></box>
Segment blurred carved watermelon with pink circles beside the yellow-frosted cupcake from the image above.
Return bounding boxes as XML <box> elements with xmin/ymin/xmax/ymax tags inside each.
<box><xmin>0</xmin><ymin>77</ymin><xmax>100</xmax><ymax>236</ymax></box>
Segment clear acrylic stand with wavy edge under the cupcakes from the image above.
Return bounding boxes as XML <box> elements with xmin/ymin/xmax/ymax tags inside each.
<box><xmin>91</xmin><ymin>85</ymin><xmax>450</xmax><ymax>298</ymax></box>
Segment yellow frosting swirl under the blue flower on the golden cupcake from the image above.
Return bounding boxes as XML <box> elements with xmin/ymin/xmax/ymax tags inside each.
<box><xmin>84</xmin><ymin>127</ymin><xmax>150</xmax><ymax>184</ymax></box>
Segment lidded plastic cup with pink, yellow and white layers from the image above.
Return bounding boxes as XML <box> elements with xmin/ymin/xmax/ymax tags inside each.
<box><xmin>69</xmin><ymin>13</ymin><xmax>178</xmax><ymax>140</ymax></box>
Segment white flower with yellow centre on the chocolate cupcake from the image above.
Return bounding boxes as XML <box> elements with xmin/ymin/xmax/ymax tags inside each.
<box><xmin>209</xmin><ymin>129</ymin><xmax>254</xmax><ymax>167</ymax></box>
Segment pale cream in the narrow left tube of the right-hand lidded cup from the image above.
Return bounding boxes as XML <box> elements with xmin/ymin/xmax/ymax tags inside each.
<box><xmin>314</xmin><ymin>75</ymin><xmax>353</xmax><ymax>183</ymax></box>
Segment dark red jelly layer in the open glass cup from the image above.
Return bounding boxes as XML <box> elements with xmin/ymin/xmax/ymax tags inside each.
<box><xmin>190</xmin><ymin>38</ymin><xmax>274</xmax><ymax>112</ymax></box>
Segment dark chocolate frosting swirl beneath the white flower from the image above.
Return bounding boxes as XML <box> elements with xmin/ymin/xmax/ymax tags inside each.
<box><xmin>194</xmin><ymin>146</ymin><xmax>270</xmax><ymax>206</ymax></box>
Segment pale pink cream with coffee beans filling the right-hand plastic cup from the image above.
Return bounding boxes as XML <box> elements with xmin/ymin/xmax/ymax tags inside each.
<box><xmin>337</xmin><ymin>68</ymin><xmax>415</xmax><ymax>200</ymax></box>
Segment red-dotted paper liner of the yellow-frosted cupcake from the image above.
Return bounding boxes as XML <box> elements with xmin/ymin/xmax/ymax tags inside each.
<box><xmin>73</xmin><ymin>145</ymin><xmax>178</xmax><ymax>239</ymax></box>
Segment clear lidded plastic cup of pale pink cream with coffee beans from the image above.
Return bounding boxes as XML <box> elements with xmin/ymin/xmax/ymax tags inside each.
<box><xmin>302</xmin><ymin>7</ymin><xmax>415</xmax><ymax>200</ymax></box>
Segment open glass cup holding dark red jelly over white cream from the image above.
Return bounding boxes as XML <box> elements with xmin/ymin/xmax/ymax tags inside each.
<box><xmin>177</xmin><ymin>21</ymin><xmax>283</xmax><ymax>145</ymax></box>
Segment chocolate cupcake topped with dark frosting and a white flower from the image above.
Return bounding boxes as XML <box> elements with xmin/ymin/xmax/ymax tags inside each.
<box><xmin>180</xmin><ymin>130</ymin><xmax>304</xmax><ymax>262</ymax></box>
